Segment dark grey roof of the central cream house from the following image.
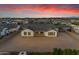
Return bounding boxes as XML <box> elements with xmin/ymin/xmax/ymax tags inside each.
<box><xmin>23</xmin><ymin>23</ymin><xmax>56</xmax><ymax>32</ymax></box>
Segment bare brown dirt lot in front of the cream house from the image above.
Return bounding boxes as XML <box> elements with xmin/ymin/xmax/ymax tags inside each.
<box><xmin>0</xmin><ymin>33</ymin><xmax>79</xmax><ymax>51</ymax></box>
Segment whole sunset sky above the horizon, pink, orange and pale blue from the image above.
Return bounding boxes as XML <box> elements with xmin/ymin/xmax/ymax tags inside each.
<box><xmin>0</xmin><ymin>4</ymin><xmax>79</xmax><ymax>17</ymax></box>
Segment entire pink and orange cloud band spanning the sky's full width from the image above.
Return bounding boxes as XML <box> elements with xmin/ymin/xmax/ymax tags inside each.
<box><xmin>0</xmin><ymin>4</ymin><xmax>79</xmax><ymax>16</ymax></box>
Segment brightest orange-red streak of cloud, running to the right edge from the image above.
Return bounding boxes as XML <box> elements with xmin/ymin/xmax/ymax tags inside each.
<box><xmin>13</xmin><ymin>6</ymin><xmax>79</xmax><ymax>14</ymax></box>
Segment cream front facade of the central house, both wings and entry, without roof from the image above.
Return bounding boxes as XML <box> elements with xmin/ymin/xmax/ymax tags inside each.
<box><xmin>21</xmin><ymin>29</ymin><xmax>57</xmax><ymax>37</ymax></box>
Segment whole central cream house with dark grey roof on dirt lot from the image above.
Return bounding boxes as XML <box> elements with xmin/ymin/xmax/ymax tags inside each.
<box><xmin>21</xmin><ymin>22</ymin><xmax>58</xmax><ymax>37</ymax></box>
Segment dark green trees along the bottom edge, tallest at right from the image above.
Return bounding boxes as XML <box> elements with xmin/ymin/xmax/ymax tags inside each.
<box><xmin>27</xmin><ymin>48</ymin><xmax>79</xmax><ymax>55</ymax></box>
